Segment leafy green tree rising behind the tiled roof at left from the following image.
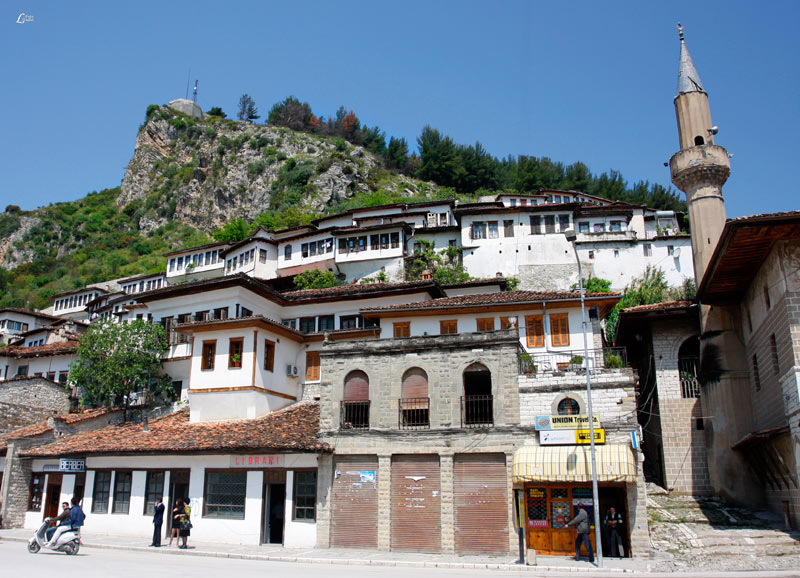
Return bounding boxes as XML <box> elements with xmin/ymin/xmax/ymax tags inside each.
<box><xmin>69</xmin><ymin>319</ymin><xmax>174</xmax><ymax>420</ymax></box>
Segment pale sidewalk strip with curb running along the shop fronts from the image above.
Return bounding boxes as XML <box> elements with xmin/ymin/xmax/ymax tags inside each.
<box><xmin>0</xmin><ymin>536</ymin><xmax>646</xmax><ymax>574</ymax></box>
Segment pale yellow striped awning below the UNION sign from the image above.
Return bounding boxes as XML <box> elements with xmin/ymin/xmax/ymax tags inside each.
<box><xmin>512</xmin><ymin>444</ymin><xmax>636</xmax><ymax>484</ymax></box>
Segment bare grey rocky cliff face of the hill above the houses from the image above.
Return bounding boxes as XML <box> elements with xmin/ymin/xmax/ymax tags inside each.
<box><xmin>117</xmin><ymin>107</ymin><xmax>435</xmax><ymax>233</ymax></box>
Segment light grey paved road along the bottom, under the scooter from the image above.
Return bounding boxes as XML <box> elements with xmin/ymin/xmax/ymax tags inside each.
<box><xmin>0</xmin><ymin>541</ymin><xmax>800</xmax><ymax>578</ymax></box>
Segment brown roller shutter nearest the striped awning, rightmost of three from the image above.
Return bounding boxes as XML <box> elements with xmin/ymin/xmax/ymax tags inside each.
<box><xmin>453</xmin><ymin>454</ymin><xmax>509</xmax><ymax>554</ymax></box>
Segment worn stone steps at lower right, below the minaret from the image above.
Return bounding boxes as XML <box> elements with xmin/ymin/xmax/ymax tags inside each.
<box><xmin>647</xmin><ymin>484</ymin><xmax>800</xmax><ymax>572</ymax></box>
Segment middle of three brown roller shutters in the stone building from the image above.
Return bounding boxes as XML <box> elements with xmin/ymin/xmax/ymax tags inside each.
<box><xmin>392</xmin><ymin>455</ymin><xmax>442</xmax><ymax>552</ymax></box>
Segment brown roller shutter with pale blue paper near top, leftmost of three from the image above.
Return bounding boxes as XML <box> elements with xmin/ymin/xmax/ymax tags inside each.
<box><xmin>331</xmin><ymin>456</ymin><xmax>378</xmax><ymax>549</ymax></box>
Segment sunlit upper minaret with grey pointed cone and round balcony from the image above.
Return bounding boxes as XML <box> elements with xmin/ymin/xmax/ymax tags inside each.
<box><xmin>669</xmin><ymin>24</ymin><xmax>731</xmax><ymax>285</ymax></box>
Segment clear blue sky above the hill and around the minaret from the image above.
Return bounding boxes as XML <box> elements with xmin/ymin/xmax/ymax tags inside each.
<box><xmin>0</xmin><ymin>0</ymin><xmax>800</xmax><ymax>217</ymax></box>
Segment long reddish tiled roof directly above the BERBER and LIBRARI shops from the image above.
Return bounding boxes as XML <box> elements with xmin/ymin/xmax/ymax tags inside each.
<box><xmin>20</xmin><ymin>402</ymin><xmax>331</xmax><ymax>457</ymax></box>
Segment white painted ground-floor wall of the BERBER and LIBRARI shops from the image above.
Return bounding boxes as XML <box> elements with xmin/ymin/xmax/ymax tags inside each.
<box><xmin>30</xmin><ymin>454</ymin><xmax>317</xmax><ymax>548</ymax></box>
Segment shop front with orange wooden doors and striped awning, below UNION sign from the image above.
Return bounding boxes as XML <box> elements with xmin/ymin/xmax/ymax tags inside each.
<box><xmin>513</xmin><ymin>444</ymin><xmax>637</xmax><ymax>556</ymax></box>
